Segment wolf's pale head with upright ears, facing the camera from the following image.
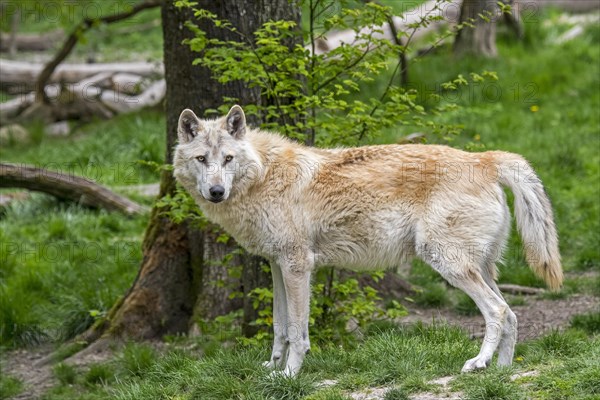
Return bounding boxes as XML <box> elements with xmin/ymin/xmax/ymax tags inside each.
<box><xmin>173</xmin><ymin>105</ymin><xmax>259</xmax><ymax>203</ymax></box>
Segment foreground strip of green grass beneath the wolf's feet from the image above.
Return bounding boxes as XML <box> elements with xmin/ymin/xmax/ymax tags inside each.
<box><xmin>28</xmin><ymin>325</ymin><xmax>477</xmax><ymax>400</ymax></box>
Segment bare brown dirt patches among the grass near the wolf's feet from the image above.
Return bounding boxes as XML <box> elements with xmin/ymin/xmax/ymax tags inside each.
<box><xmin>1</xmin><ymin>284</ymin><xmax>600</xmax><ymax>400</ymax></box>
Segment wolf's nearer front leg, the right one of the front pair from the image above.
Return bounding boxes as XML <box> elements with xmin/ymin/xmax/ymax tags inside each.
<box><xmin>281</xmin><ymin>262</ymin><xmax>312</xmax><ymax>376</ymax></box>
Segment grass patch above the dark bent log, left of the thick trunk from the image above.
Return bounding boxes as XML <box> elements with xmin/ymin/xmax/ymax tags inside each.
<box><xmin>0</xmin><ymin>110</ymin><xmax>165</xmax><ymax>186</ymax></box>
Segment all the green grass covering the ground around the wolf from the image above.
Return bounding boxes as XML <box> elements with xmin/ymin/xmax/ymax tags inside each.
<box><xmin>0</xmin><ymin>3</ymin><xmax>600</xmax><ymax>400</ymax></box>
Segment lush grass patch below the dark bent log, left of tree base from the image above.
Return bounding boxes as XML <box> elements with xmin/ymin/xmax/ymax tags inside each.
<box><xmin>0</xmin><ymin>196</ymin><xmax>146</xmax><ymax>346</ymax></box>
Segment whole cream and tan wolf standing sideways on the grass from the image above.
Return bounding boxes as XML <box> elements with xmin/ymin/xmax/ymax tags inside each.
<box><xmin>173</xmin><ymin>105</ymin><xmax>563</xmax><ymax>375</ymax></box>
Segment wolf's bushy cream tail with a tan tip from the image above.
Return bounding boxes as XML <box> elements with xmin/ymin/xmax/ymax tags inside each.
<box><xmin>495</xmin><ymin>152</ymin><xmax>563</xmax><ymax>290</ymax></box>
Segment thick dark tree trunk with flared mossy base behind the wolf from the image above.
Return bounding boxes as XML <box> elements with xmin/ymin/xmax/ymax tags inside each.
<box><xmin>87</xmin><ymin>0</ymin><xmax>300</xmax><ymax>346</ymax></box>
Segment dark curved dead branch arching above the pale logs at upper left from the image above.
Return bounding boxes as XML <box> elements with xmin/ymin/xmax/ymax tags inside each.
<box><xmin>36</xmin><ymin>0</ymin><xmax>163</xmax><ymax>103</ymax></box>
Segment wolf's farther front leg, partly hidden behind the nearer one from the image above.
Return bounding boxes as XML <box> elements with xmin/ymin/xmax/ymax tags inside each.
<box><xmin>265</xmin><ymin>262</ymin><xmax>288</xmax><ymax>368</ymax></box>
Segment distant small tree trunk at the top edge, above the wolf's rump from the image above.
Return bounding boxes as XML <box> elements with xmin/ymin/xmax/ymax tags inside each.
<box><xmin>454</xmin><ymin>0</ymin><xmax>500</xmax><ymax>57</ymax></box>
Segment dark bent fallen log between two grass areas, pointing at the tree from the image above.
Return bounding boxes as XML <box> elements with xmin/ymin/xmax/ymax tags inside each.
<box><xmin>0</xmin><ymin>163</ymin><xmax>147</xmax><ymax>215</ymax></box>
